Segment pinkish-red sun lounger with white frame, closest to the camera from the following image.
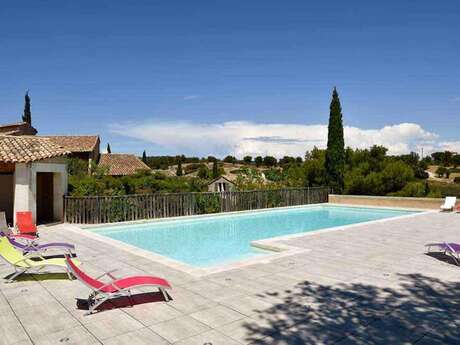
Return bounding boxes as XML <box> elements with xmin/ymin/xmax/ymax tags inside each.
<box><xmin>65</xmin><ymin>254</ymin><xmax>171</xmax><ymax>314</ymax></box>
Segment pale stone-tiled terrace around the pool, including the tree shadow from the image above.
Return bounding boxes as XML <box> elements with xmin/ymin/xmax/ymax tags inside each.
<box><xmin>0</xmin><ymin>213</ymin><xmax>460</xmax><ymax>345</ymax></box>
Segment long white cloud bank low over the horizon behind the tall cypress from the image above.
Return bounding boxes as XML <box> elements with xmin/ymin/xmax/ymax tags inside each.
<box><xmin>110</xmin><ymin>121</ymin><xmax>452</xmax><ymax>157</ymax></box>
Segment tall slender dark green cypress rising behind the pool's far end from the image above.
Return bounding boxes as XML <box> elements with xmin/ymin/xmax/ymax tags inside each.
<box><xmin>325</xmin><ymin>87</ymin><xmax>345</xmax><ymax>193</ymax></box>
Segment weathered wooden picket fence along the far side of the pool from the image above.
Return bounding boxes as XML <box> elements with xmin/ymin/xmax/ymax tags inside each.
<box><xmin>64</xmin><ymin>187</ymin><xmax>331</xmax><ymax>224</ymax></box>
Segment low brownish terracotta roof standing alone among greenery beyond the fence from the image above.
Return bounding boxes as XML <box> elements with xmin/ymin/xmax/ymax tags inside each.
<box><xmin>99</xmin><ymin>153</ymin><xmax>150</xmax><ymax>176</ymax></box>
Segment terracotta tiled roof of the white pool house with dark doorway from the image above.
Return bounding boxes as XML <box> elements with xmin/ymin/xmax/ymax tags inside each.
<box><xmin>0</xmin><ymin>135</ymin><xmax>70</xmax><ymax>163</ymax></box>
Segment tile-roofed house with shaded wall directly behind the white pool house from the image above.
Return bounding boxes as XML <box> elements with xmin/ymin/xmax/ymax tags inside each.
<box><xmin>43</xmin><ymin>135</ymin><xmax>101</xmax><ymax>164</ymax></box>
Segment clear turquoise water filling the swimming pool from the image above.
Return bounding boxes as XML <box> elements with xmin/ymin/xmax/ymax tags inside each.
<box><xmin>92</xmin><ymin>205</ymin><xmax>414</xmax><ymax>267</ymax></box>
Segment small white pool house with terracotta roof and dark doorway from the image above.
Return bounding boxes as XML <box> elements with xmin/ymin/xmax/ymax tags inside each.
<box><xmin>0</xmin><ymin>134</ymin><xmax>69</xmax><ymax>223</ymax></box>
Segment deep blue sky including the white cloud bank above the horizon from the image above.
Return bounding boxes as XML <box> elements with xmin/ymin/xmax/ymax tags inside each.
<box><xmin>0</xmin><ymin>0</ymin><xmax>460</xmax><ymax>157</ymax></box>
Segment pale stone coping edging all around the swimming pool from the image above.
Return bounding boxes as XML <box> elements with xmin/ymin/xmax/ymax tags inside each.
<box><xmin>68</xmin><ymin>203</ymin><xmax>438</xmax><ymax>278</ymax></box>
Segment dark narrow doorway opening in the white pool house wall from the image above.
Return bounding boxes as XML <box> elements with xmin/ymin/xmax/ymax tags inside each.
<box><xmin>37</xmin><ymin>173</ymin><xmax>54</xmax><ymax>224</ymax></box>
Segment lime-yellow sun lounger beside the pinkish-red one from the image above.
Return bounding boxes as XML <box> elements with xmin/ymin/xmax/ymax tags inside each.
<box><xmin>0</xmin><ymin>236</ymin><xmax>80</xmax><ymax>283</ymax></box>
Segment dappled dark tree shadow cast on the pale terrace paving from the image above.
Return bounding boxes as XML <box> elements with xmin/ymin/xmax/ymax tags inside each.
<box><xmin>245</xmin><ymin>274</ymin><xmax>460</xmax><ymax>345</ymax></box>
